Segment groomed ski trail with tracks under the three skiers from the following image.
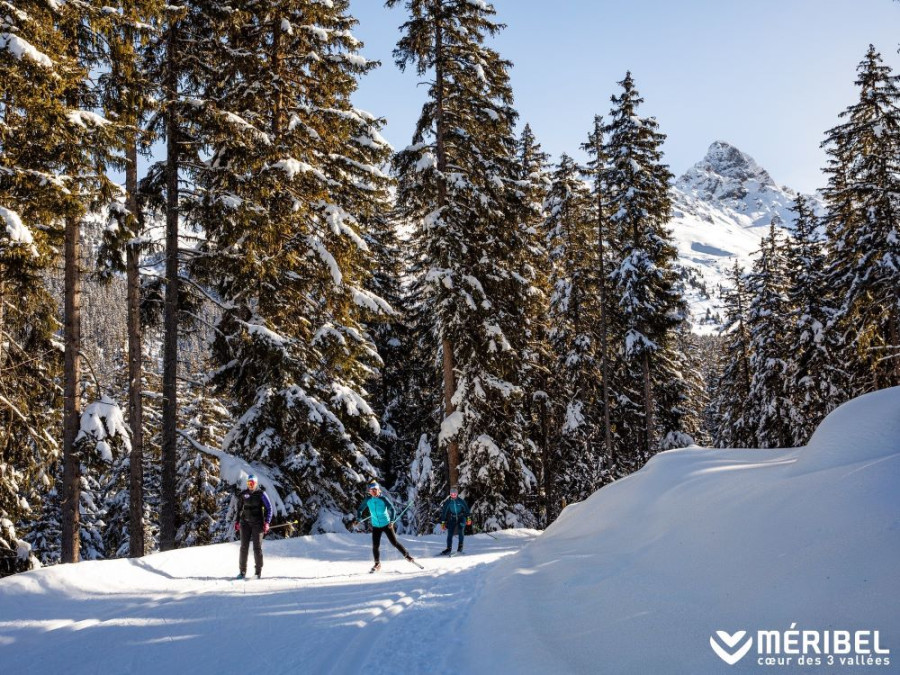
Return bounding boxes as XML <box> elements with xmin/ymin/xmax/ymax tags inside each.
<box><xmin>0</xmin><ymin>533</ymin><xmax>537</xmax><ymax>675</ymax></box>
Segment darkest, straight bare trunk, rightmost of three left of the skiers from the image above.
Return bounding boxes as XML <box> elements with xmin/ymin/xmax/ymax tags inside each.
<box><xmin>159</xmin><ymin>23</ymin><xmax>179</xmax><ymax>551</ymax></box>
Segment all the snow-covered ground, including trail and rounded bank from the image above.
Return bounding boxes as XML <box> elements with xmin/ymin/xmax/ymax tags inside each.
<box><xmin>0</xmin><ymin>388</ymin><xmax>900</xmax><ymax>675</ymax></box>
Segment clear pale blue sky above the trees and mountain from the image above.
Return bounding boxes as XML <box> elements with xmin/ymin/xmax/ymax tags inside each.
<box><xmin>350</xmin><ymin>0</ymin><xmax>900</xmax><ymax>192</ymax></box>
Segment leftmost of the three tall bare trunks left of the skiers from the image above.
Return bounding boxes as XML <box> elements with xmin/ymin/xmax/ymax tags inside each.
<box><xmin>60</xmin><ymin>216</ymin><xmax>81</xmax><ymax>563</ymax></box>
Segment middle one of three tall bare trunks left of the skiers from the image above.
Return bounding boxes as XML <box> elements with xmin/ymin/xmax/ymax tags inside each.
<box><xmin>125</xmin><ymin>134</ymin><xmax>146</xmax><ymax>558</ymax></box>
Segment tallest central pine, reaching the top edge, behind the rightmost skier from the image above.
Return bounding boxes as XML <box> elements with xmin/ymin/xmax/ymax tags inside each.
<box><xmin>387</xmin><ymin>0</ymin><xmax>536</xmax><ymax>529</ymax></box>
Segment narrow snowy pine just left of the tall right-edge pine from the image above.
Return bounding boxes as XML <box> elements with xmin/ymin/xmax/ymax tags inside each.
<box><xmin>785</xmin><ymin>195</ymin><xmax>848</xmax><ymax>445</ymax></box>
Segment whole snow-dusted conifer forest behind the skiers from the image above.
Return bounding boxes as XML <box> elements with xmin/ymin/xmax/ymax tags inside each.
<box><xmin>0</xmin><ymin>0</ymin><xmax>900</xmax><ymax>575</ymax></box>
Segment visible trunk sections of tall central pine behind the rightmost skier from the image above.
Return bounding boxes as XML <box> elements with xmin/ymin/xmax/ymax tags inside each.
<box><xmin>434</xmin><ymin>5</ymin><xmax>459</xmax><ymax>486</ymax></box>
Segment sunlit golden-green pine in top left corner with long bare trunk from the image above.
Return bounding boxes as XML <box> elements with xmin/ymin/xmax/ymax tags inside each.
<box><xmin>0</xmin><ymin>2</ymin><xmax>120</xmax><ymax>561</ymax></box>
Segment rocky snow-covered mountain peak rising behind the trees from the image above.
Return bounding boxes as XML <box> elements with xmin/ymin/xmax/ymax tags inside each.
<box><xmin>669</xmin><ymin>141</ymin><xmax>820</xmax><ymax>333</ymax></box>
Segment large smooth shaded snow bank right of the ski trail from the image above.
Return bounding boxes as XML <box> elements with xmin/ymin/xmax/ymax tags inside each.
<box><xmin>462</xmin><ymin>387</ymin><xmax>900</xmax><ymax>673</ymax></box>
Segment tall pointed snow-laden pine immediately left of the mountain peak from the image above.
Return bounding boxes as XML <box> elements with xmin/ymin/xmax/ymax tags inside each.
<box><xmin>604</xmin><ymin>73</ymin><xmax>686</xmax><ymax>468</ymax></box>
